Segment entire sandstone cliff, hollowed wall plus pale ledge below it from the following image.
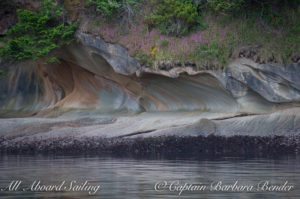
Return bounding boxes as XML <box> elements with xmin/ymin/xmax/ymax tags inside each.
<box><xmin>0</xmin><ymin>33</ymin><xmax>300</xmax><ymax>139</ymax></box>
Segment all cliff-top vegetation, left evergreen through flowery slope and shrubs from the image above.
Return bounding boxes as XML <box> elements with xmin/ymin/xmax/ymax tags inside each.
<box><xmin>0</xmin><ymin>0</ymin><xmax>300</xmax><ymax>69</ymax></box>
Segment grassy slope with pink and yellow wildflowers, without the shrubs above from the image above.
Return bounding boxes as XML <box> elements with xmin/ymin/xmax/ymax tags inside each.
<box><xmin>87</xmin><ymin>1</ymin><xmax>300</xmax><ymax>69</ymax></box>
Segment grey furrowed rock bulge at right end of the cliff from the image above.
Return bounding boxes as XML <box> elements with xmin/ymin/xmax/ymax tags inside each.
<box><xmin>225</xmin><ymin>59</ymin><xmax>300</xmax><ymax>103</ymax></box>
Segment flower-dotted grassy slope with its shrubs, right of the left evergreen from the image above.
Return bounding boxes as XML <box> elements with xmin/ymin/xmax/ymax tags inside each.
<box><xmin>87</xmin><ymin>0</ymin><xmax>300</xmax><ymax>69</ymax></box>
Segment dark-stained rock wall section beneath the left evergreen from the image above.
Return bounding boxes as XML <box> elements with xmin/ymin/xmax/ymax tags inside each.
<box><xmin>0</xmin><ymin>62</ymin><xmax>45</xmax><ymax>117</ymax></box>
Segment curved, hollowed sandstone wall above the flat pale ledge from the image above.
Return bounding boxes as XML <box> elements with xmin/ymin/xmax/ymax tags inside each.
<box><xmin>0</xmin><ymin>33</ymin><xmax>300</xmax><ymax>116</ymax></box>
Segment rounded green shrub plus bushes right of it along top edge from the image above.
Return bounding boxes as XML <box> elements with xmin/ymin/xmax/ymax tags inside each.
<box><xmin>146</xmin><ymin>0</ymin><xmax>300</xmax><ymax>36</ymax></box>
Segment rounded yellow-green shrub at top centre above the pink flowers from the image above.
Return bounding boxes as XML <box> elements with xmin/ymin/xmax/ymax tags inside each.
<box><xmin>147</xmin><ymin>0</ymin><xmax>201</xmax><ymax>36</ymax></box>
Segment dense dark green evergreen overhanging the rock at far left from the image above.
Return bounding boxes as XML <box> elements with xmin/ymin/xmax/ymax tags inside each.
<box><xmin>0</xmin><ymin>0</ymin><xmax>77</xmax><ymax>61</ymax></box>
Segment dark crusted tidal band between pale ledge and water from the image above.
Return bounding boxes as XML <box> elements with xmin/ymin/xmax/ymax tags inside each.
<box><xmin>0</xmin><ymin>135</ymin><xmax>300</xmax><ymax>157</ymax></box>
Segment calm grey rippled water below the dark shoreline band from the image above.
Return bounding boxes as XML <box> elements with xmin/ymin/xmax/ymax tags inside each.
<box><xmin>0</xmin><ymin>155</ymin><xmax>300</xmax><ymax>199</ymax></box>
